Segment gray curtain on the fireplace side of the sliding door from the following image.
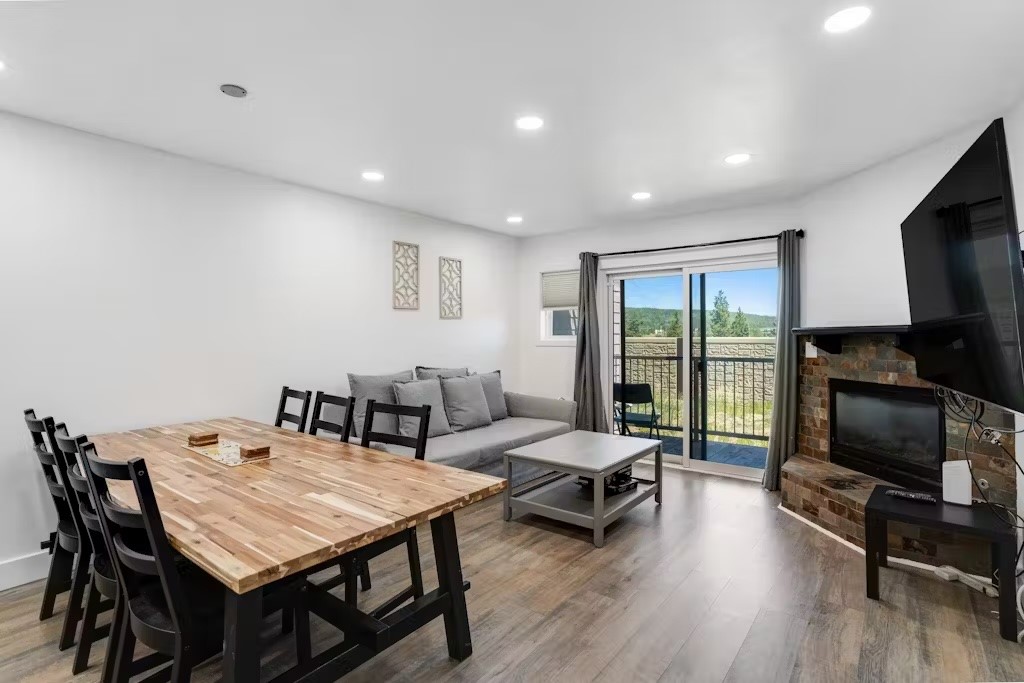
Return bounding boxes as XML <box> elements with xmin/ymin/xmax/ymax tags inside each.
<box><xmin>761</xmin><ymin>230</ymin><xmax>800</xmax><ymax>490</ymax></box>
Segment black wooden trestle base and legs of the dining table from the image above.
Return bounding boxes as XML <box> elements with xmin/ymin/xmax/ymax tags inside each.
<box><xmin>223</xmin><ymin>512</ymin><xmax>473</xmax><ymax>683</ymax></box>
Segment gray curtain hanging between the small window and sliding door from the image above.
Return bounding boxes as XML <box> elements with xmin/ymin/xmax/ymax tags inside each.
<box><xmin>572</xmin><ymin>252</ymin><xmax>608</xmax><ymax>432</ymax></box>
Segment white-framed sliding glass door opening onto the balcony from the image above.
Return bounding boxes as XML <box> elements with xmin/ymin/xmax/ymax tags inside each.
<box><xmin>608</xmin><ymin>258</ymin><xmax>778</xmax><ymax>478</ymax></box>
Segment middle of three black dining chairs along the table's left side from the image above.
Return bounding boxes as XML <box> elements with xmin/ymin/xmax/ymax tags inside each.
<box><xmin>54</xmin><ymin>424</ymin><xmax>119</xmax><ymax>681</ymax></box>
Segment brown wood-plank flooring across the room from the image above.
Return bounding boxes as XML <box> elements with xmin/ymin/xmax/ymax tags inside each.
<box><xmin>0</xmin><ymin>469</ymin><xmax>1024</xmax><ymax>683</ymax></box>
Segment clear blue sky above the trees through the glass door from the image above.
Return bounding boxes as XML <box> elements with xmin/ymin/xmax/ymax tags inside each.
<box><xmin>626</xmin><ymin>268</ymin><xmax>778</xmax><ymax>315</ymax></box>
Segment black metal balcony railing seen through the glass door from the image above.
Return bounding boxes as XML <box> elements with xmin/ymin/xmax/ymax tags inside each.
<box><xmin>614</xmin><ymin>355</ymin><xmax>775</xmax><ymax>441</ymax></box>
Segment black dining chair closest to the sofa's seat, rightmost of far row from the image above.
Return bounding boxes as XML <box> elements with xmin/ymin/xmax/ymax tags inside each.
<box><xmin>345</xmin><ymin>398</ymin><xmax>430</xmax><ymax>617</ymax></box>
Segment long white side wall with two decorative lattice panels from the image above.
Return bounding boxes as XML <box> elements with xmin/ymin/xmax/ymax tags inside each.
<box><xmin>0</xmin><ymin>115</ymin><xmax>517</xmax><ymax>588</ymax></box>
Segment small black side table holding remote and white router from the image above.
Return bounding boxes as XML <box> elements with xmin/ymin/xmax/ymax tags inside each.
<box><xmin>864</xmin><ymin>485</ymin><xmax>1017</xmax><ymax>642</ymax></box>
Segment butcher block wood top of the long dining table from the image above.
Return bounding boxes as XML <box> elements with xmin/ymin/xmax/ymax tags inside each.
<box><xmin>91</xmin><ymin>418</ymin><xmax>507</xmax><ymax>593</ymax></box>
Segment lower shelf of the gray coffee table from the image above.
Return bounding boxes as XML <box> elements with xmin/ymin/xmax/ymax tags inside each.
<box><xmin>509</xmin><ymin>474</ymin><xmax>658</xmax><ymax>547</ymax></box>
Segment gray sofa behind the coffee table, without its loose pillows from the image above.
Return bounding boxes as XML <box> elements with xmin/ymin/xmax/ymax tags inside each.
<box><xmin>349</xmin><ymin>369</ymin><xmax>577</xmax><ymax>486</ymax></box>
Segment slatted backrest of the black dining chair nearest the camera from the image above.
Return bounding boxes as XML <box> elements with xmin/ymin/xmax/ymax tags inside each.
<box><xmin>81</xmin><ymin>450</ymin><xmax>191</xmax><ymax>633</ymax></box>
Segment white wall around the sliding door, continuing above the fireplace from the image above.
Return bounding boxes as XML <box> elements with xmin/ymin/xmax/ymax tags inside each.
<box><xmin>518</xmin><ymin>103</ymin><xmax>1024</xmax><ymax>397</ymax></box>
